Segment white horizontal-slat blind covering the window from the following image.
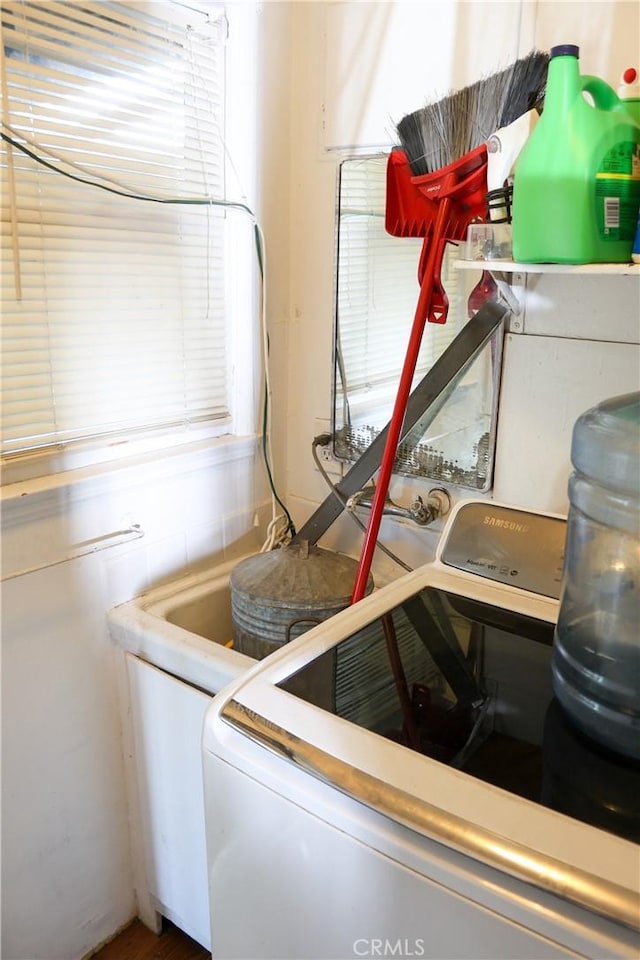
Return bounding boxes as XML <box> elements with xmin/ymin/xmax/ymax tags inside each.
<box><xmin>1</xmin><ymin>0</ymin><xmax>241</xmax><ymax>453</ymax></box>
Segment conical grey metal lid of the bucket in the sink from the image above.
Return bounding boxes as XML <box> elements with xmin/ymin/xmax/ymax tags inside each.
<box><xmin>229</xmin><ymin>540</ymin><xmax>373</xmax><ymax>607</ymax></box>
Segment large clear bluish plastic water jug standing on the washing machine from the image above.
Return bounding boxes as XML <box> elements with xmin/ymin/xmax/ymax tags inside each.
<box><xmin>552</xmin><ymin>393</ymin><xmax>640</xmax><ymax>760</ymax></box>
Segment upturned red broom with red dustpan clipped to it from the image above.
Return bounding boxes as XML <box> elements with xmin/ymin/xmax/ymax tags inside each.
<box><xmin>351</xmin><ymin>53</ymin><xmax>548</xmax><ymax>603</ymax></box>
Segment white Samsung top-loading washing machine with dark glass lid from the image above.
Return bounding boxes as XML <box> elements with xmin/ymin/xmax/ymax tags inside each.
<box><xmin>203</xmin><ymin>500</ymin><xmax>640</xmax><ymax>960</ymax></box>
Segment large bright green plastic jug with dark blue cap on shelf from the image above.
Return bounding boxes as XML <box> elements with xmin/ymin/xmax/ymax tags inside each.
<box><xmin>512</xmin><ymin>44</ymin><xmax>640</xmax><ymax>263</ymax></box>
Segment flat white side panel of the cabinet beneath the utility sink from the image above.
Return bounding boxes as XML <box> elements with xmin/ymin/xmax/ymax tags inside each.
<box><xmin>125</xmin><ymin>653</ymin><xmax>211</xmax><ymax>949</ymax></box>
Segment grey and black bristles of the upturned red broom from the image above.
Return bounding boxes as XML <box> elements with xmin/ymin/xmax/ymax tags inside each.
<box><xmin>396</xmin><ymin>51</ymin><xmax>549</xmax><ymax>177</ymax></box>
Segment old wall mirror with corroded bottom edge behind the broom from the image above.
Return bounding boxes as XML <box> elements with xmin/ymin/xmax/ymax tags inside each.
<box><xmin>331</xmin><ymin>155</ymin><xmax>502</xmax><ymax>493</ymax></box>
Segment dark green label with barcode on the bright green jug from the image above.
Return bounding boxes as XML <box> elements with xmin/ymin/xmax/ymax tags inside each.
<box><xmin>596</xmin><ymin>140</ymin><xmax>640</xmax><ymax>243</ymax></box>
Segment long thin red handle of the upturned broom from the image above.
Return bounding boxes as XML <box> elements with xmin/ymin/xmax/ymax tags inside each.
<box><xmin>351</xmin><ymin>197</ymin><xmax>451</xmax><ymax>603</ymax></box>
